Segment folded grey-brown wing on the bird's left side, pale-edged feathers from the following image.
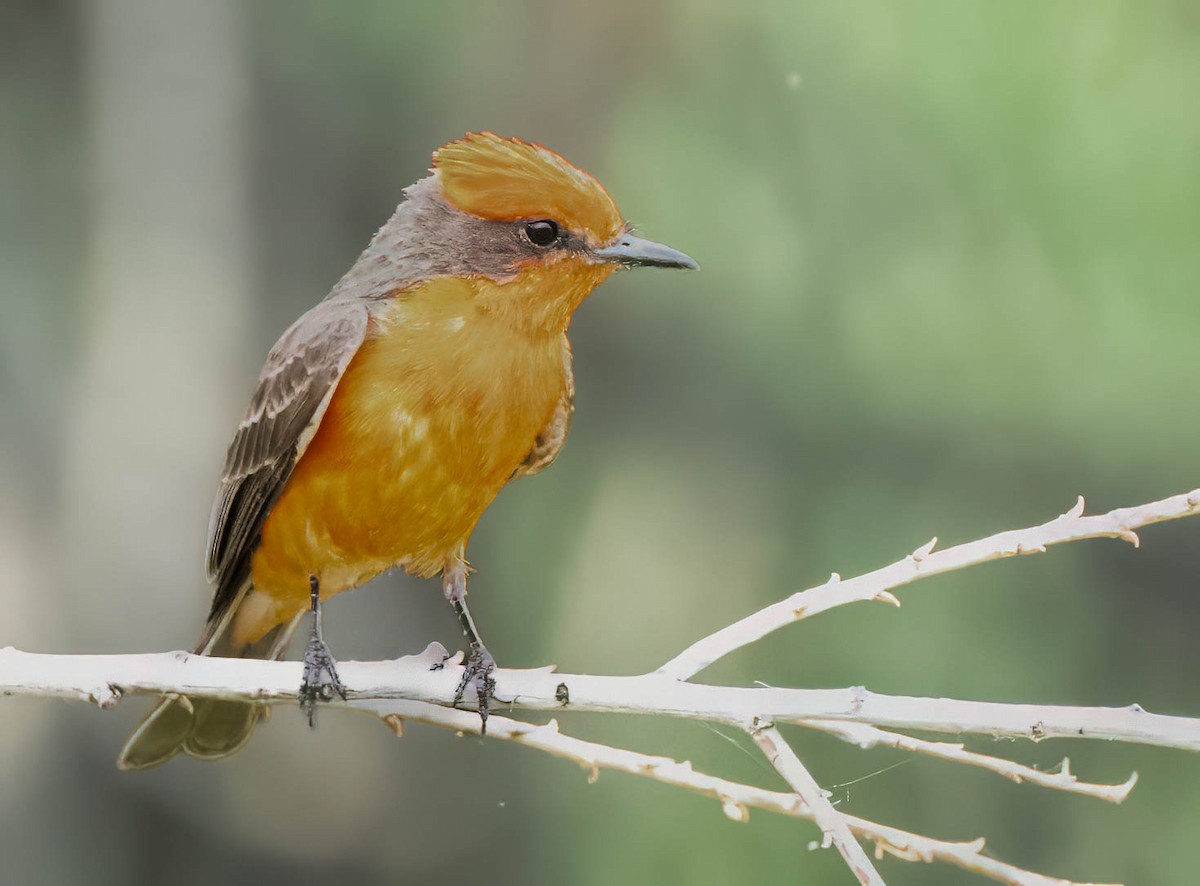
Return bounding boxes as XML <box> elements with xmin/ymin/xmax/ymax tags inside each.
<box><xmin>206</xmin><ymin>300</ymin><xmax>368</xmax><ymax>623</ymax></box>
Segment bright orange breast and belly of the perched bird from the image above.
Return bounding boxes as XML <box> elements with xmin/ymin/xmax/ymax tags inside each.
<box><xmin>234</xmin><ymin>277</ymin><xmax>566</xmax><ymax>642</ymax></box>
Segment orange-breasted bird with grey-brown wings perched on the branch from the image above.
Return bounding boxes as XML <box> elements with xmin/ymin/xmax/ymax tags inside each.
<box><xmin>118</xmin><ymin>131</ymin><xmax>697</xmax><ymax>770</ymax></box>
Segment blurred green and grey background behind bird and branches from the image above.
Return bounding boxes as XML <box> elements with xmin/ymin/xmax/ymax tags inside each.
<box><xmin>0</xmin><ymin>0</ymin><xmax>1200</xmax><ymax>886</ymax></box>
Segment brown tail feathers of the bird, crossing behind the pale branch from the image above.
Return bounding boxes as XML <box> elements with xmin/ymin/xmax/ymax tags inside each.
<box><xmin>116</xmin><ymin>605</ymin><xmax>300</xmax><ymax>770</ymax></box>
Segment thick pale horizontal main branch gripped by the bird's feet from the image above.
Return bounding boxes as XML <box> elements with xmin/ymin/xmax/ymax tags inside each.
<box><xmin>0</xmin><ymin>643</ymin><xmax>1200</xmax><ymax>750</ymax></box>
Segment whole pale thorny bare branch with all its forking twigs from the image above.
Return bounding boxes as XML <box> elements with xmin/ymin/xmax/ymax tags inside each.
<box><xmin>0</xmin><ymin>490</ymin><xmax>1200</xmax><ymax>886</ymax></box>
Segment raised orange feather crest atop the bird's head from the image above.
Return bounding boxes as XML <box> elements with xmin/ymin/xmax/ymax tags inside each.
<box><xmin>433</xmin><ymin>132</ymin><xmax>624</xmax><ymax>243</ymax></box>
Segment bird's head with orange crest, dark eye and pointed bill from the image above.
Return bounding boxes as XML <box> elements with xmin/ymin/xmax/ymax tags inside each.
<box><xmin>343</xmin><ymin>132</ymin><xmax>696</xmax><ymax>329</ymax></box>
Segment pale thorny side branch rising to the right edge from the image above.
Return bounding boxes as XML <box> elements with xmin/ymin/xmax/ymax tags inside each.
<box><xmin>659</xmin><ymin>489</ymin><xmax>1200</xmax><ymax>680</ymax></box>
